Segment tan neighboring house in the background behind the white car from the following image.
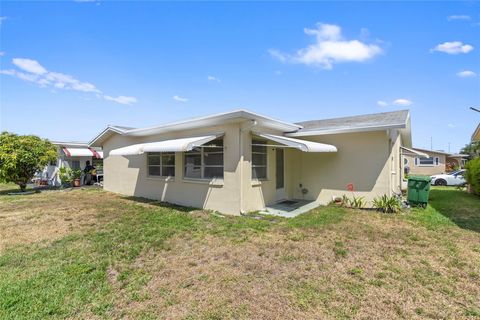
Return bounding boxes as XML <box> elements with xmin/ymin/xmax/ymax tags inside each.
<box><xmin>403</xmin><ymin>148</ymin><xmax>468</xmax><ymax>176</ymax></box>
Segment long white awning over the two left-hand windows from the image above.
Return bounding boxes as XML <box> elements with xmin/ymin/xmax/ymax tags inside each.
<box><xmin>110</xmin><ymin>133</ymin><xmax>223</xmax><ymax>156</ymax></box>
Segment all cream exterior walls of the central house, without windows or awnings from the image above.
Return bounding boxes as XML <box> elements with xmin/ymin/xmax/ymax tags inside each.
<box><xmin>103</xmin><ymin>126</ymin><xmax>401</xmax><ymax>215</ymax></box>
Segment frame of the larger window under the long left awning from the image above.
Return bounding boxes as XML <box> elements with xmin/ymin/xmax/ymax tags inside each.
<box><xmin>182</xmin><ymin>138</ymin><xmax>225</xmax><ymax>181</ymax></box>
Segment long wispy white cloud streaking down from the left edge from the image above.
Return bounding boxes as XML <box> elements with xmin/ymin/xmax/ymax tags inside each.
<box><xmin>0</xmin><ymin>58</ymin><xmax>137</xmax><ymax>104</ymax></box>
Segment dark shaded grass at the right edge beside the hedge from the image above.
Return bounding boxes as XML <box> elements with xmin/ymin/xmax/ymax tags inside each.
<box><xmin>429</xmin><ymin>187</ymin><xmax>480</xmax><ymax>232</ymax></box>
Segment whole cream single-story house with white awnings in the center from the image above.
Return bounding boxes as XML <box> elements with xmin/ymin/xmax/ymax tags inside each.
<box><xmin>90</xmin><ymin>110</ymin><xmax>411</xmax><ymax>215</ymax></box>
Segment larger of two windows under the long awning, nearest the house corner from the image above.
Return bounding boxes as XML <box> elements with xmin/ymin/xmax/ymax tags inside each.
<box><xmin>184</xmin><ymin>139</ymin><xmax>223</xmax><ymax>179</ymax></box>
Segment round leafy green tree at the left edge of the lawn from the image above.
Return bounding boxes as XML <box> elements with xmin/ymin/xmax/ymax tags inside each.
<box><xmin>0</xmin><ymin>132</ymin><xmax>57</xmax><ymax>191</ymax></box>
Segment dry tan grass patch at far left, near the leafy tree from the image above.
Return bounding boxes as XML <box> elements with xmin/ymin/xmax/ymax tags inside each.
<box><xmin>0</xmin><ymin>189</ymin><xmax>122</xmax><ymax>252</ymax></box>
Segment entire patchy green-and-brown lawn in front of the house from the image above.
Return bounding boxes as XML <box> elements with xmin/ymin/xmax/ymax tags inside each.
<box><xmin>0</xmin><ymin>186</ymin><xmax>480</xmax><ymax>319</ymax></box>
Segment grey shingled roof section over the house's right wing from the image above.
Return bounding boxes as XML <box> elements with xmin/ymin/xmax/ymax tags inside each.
<box><xmin>290</xmin><ymin>110</ymin><xmax>409</xmax><ymax>136</ymax></box>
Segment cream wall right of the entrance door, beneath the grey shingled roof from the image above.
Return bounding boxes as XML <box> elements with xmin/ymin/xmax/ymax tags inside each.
<box><xmin>292</xmin><ymin>131</ymin><xmax>400</xmax><ymax>204</ymax></box>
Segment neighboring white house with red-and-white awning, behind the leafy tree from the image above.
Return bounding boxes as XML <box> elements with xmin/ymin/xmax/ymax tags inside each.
<box><xmin>37</xmin><ymin>141</ymin><xmax>103</xmax><ymax>186</ymax></box>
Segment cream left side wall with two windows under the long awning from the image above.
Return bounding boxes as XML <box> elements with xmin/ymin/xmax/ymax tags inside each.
<box><xmin>103</xmin><ymin>123</ymin><xmax>241</xmax><ymax>215</ymax></box>
